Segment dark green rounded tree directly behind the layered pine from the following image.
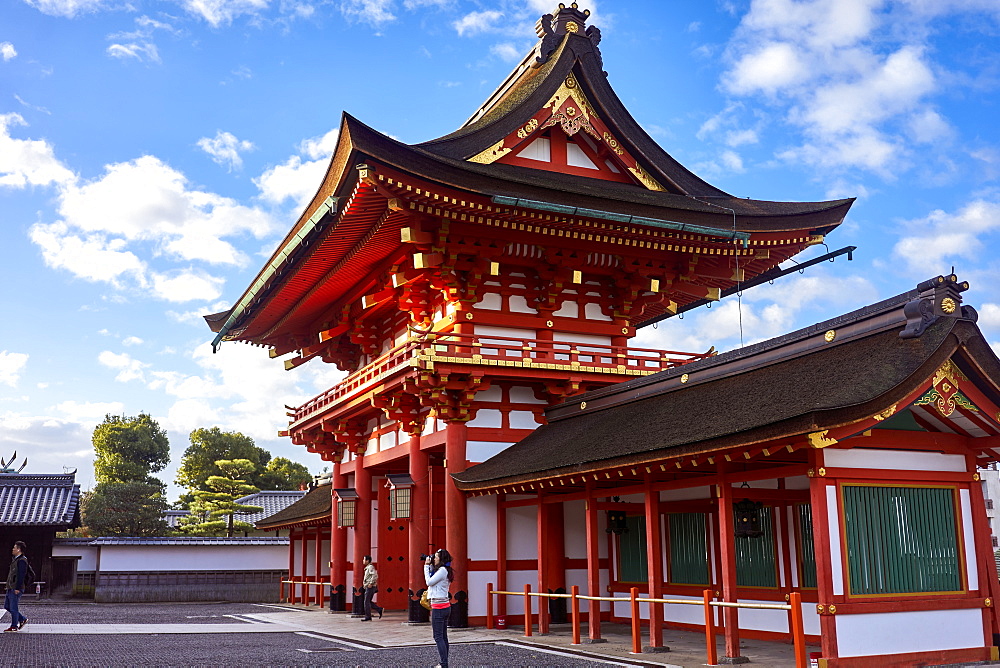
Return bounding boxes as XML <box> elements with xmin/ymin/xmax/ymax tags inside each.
<box><xmin>177</xmin><ymin>427</ymin><xmax>271</xmax><ymax>503</ymax></box>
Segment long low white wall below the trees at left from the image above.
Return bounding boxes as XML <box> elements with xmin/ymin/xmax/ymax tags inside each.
<box><xmin>101</xmin><ymin>543</ymin><xmax>288</xmax><ymax>572</ymax></box>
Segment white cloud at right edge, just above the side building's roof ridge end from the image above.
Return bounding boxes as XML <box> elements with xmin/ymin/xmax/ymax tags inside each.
<box><xmin>893</xmin><ymin>199</ymin><xmax>1000</xmax><ymax>278</ymax></box>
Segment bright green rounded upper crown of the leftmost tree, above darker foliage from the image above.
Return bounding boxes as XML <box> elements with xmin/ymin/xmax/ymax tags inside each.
<box><xmin>93</xmin><ymin>413</ymin><xmax>170</xmax><ymax>484</ymax></box>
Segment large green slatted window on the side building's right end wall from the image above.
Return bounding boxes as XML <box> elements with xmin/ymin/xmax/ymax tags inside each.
<box><xmin>842</xmin><ymin>485</ymin><xmax>962</xmax><ymax>595</ymax></box>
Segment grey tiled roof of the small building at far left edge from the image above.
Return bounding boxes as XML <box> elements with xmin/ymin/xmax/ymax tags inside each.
<box><xmin>0</xmin><ymin>473</ymin><xmax>80</xmax><ymax>529</ymax></box>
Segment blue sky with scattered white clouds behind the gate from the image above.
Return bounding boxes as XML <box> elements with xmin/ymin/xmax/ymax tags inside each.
<box><xmin>0</xmin><ymin>0</ymin><xmax>1000</xmax><ymax>496</ymax></box>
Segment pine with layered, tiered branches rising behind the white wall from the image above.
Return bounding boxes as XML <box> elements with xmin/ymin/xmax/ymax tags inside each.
<box><xmin>181</xmin><ymin>459</ymin><xmax>263</xmax><ymax>536</ymax></box>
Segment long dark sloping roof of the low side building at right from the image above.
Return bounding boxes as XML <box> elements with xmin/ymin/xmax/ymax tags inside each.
<box><xmin>454</xmin><ymin>293</ymin><xmax>1000</xmax><ymax>490</ymax></box>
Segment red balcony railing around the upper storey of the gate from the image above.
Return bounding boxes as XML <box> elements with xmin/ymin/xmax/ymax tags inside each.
<box><xmin>292</xmin><ymin>334</ymin><xmax>714</xmax><ymax>425</ymax></box>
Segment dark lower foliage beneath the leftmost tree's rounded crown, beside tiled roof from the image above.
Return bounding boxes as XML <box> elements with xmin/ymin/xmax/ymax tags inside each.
<box><xmin>81</xmin><ymin>481</ymin><xmax>167</xmax><ymax>536</ymax></box>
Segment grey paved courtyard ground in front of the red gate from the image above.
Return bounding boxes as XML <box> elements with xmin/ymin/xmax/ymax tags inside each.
<box><xmin>0</xmin><ymin>601</ymin><xmax>816</xmax><ymax>668</ymax></box>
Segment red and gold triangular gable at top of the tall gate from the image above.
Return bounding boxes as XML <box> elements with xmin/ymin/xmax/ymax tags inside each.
<box><xmin>469</xmin><ymin>73</ymin><xmax>666</xmax><ymax>191</ymax></box>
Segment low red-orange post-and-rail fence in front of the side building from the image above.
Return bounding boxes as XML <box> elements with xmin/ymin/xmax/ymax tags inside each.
<box><xmin>486</xmin><ymin>582</ymin><xmax>809</xmax><ymax>668</ymax></box>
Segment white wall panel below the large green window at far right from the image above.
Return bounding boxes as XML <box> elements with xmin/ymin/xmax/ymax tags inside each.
<box><xmin>837</xmin><ymin>608</ymin><xmax>986</xmax><ymax>657</ymax></box>
